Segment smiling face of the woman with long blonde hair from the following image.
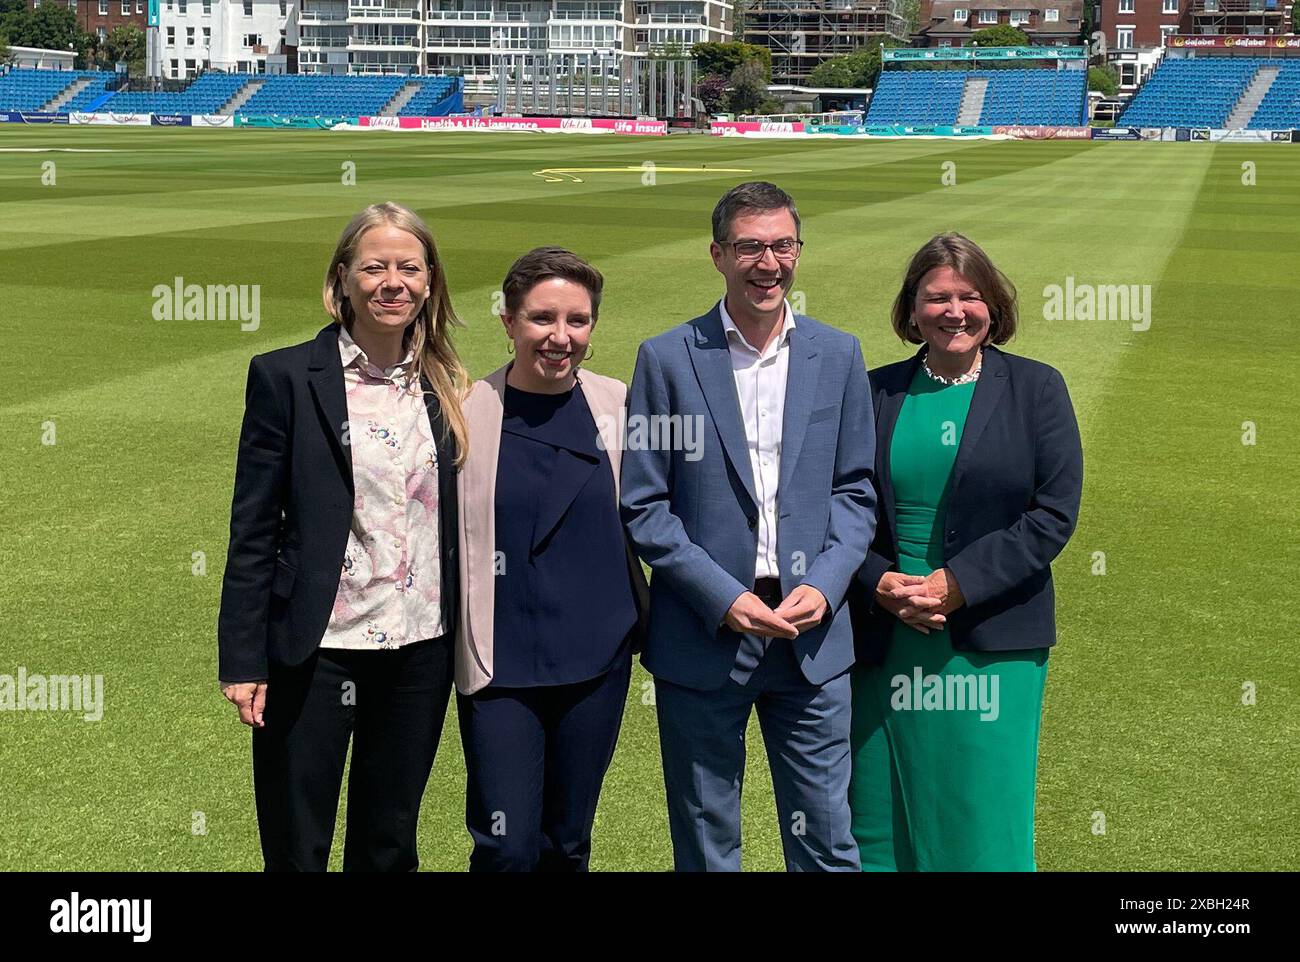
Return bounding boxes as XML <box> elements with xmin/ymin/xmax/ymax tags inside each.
<box><xmin>338</xmin><ymin>224</ymin><xmax>430</xmax><ymax>334</ymax></box>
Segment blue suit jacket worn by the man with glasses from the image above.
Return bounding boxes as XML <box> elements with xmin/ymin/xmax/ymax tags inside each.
<box><xmin>621</xmin><ymin>306</ymin><xmax>875</xmax><ymax>690</ymax></box>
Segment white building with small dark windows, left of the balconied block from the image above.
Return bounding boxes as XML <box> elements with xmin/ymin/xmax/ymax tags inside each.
<box><xmin>157</xmin><ymin>0</ymin><xmax>299</xmax><ymax>78</ymax></box>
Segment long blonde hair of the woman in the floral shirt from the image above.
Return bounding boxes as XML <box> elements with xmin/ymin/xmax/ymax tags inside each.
<box><xmin>321</xmin><ymin>202</ymin><xmax>469</xmax><ymax>468</ymax></box>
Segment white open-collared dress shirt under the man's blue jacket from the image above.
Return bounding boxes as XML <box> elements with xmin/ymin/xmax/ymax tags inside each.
<box><xmin>718</xmin><ymin>298</ymin><xmax>794</xmax><ymax>579</ymax></box>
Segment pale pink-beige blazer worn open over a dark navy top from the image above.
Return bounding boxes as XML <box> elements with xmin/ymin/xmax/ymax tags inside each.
<box><xmin>456</xmin><ymin>364</ymin><xmax>649</xmax><ymax>694</ymax></box>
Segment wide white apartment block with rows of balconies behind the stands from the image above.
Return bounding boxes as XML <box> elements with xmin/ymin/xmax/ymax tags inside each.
<box><xmin>297</xmin><ymin>0</ymin><xmax>732</xmax><ymax>81</ymax></box>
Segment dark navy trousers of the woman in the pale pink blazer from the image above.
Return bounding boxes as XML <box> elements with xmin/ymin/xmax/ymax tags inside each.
<box><xmin>456</xmin><ymin>655</ymin><xmax>632</xmax><ymax>872</ymax></box>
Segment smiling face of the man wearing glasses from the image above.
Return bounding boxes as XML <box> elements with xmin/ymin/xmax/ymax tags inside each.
<box><xmin>709</xmin><ymin>208</ymin><xmax>798</xmax><ymax>319</ymax></box>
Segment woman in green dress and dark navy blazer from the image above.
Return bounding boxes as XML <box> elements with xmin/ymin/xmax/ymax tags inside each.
<box><xmin>849</xmin><ymin>234</ymin><xmax>1083</xmax><ymax>871</ymax></box>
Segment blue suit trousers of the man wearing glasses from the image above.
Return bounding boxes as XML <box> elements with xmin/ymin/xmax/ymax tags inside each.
<box><xmin>655</xmin><ymin>638</ymin><xmax>859</xmax><ymax>872</ymax></box>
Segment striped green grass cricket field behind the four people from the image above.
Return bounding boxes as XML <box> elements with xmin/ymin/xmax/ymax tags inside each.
<box><xmin>0</xmin><ymin>126</ymin><xmax>1300</xmax><ymax>870</ymax></box>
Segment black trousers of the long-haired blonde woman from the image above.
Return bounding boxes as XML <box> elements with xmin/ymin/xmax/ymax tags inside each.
<box><xmin>252</xmin><ymin>634</ymin><xmax>452</xmax><ymax>872</ymax></box>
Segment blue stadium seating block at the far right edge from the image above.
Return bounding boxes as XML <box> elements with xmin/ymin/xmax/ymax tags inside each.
<box><xmin>1119</xmin><ymin>57</ymin><xmax>1300</xmax><ymax>130</ymax></box>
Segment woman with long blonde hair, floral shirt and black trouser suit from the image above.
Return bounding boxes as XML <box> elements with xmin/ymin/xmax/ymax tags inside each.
<box><xmin>218</xmin><ymin>204</ymin><xmax>468</xmax><ymax>871</ymax></box>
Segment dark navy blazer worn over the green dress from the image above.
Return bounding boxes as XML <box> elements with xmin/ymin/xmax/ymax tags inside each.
<box><xmin>850</xmin><ymin>346</ymin><xmax>1083</xmax><ymax>663</ymax></box>
